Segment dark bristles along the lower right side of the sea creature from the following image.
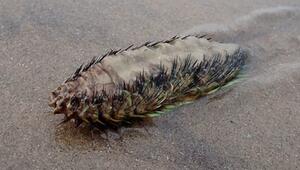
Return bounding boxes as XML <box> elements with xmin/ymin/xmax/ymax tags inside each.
<box><xmin>79</xmin><ymin>51</ymin><xmax>245</xmax><ymax>129</ymax></box>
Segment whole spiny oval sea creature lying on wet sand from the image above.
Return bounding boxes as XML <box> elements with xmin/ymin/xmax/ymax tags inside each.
<box><xmin>49</xmin><ymin>35</ymin><xmax>247</xmax><ymax>130</ymax></box>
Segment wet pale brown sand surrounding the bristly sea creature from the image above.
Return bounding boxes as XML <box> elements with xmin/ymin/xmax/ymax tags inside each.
<box><xmin>0</xmin><ymin>0</ymin><xmax>300</xmax><ymax>169</ymax></box>
